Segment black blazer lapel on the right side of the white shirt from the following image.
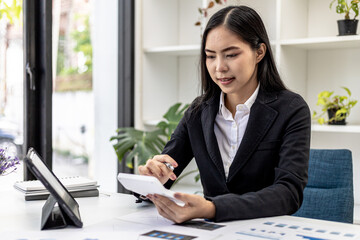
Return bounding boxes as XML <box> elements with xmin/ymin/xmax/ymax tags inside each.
<box><xmin>228</xmin><ymin>89</ymin><xmax>278</xmax><ymax>181</ymax></box>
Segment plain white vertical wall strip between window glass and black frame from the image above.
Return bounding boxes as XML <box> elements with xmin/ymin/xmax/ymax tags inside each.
<box><xmin>89</xmin><ymin>0</ymin><xmax>118</xmax><ymax>192</ymax></box>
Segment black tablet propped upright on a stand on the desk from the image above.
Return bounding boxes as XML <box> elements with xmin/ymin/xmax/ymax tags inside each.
<box><xmin>24</xmin><ymin>148</ymin><xmax>83</xmax><ymax>227</ymax></box>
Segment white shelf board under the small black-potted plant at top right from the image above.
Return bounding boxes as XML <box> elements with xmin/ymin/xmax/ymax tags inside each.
<box><xmin>280</xmin><ymin>35</ymin><xmax>360</xmax><ymax>49</ymax></box>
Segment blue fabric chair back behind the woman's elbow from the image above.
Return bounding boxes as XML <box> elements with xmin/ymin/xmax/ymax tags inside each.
<box><xmin>294</xmin><ymin>149</ymin><xmax>354</xmax><ymax>223</ymax></box>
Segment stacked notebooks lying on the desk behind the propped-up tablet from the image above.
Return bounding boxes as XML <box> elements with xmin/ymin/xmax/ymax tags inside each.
<box><xmin>14</xmin><ymin>176</ymin><xmax>99</xmax><ymax>201</ymax></box>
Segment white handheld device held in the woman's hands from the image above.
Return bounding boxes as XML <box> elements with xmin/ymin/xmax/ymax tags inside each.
<box><xmin>118</xmin><ymin>173</ymin><xmax>185</xmax><ymax>206</ymax></box>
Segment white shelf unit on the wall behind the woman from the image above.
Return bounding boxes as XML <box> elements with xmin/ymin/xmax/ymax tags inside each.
<box><xmin>135</xmin><ymin>0</ymin><xmax>360</xmax><ymax>209</ymax></box>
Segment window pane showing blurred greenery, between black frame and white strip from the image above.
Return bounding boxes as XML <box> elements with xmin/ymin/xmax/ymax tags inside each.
<box><xmin>52</xmin><ymin>0</ymin><xmax>94</xmax><ymax>176</ymax></box>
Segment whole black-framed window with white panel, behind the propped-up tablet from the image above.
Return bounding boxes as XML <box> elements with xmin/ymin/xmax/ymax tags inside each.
<box><xmin>20</xmin><ymin>0</ymin><xmax>134</xmax><ymax>191</ymax></box>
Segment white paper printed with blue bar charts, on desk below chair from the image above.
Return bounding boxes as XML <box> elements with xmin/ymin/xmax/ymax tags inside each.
<box><xmin>220</xmin><ymin>221</ymin><xmax>360</xmax><ymax>240</ymax></box>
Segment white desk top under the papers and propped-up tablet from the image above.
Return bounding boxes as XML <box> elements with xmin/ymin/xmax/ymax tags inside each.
<box><xmin>0</xmin><ymin>175</ymin><xmax>360</xmax><ymax>240</ymax></box>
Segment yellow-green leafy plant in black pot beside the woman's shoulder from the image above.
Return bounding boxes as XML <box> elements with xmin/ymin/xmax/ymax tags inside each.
<box><xmin>313</xmin><ymin>87</ymin><xmax>357</xmax><ymax>125</ymax></box>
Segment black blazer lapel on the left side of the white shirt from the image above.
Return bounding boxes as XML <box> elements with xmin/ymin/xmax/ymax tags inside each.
<box><xmin>201</xmin><ymin>94</ymin><xmax>225</xmax><ymax>179</ymax></box>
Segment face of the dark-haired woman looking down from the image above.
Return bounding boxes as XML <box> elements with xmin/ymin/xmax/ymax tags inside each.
<box><xmin>204</xmin><ymin>25</ymin><xmax>265</xmax><ymax>104</ymax></box>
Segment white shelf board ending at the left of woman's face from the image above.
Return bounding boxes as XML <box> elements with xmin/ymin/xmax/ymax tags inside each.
<box><xmin>144</xmin><ymin>45</ymin><xmax>200</xmax><ymax>56</ymax></box>
